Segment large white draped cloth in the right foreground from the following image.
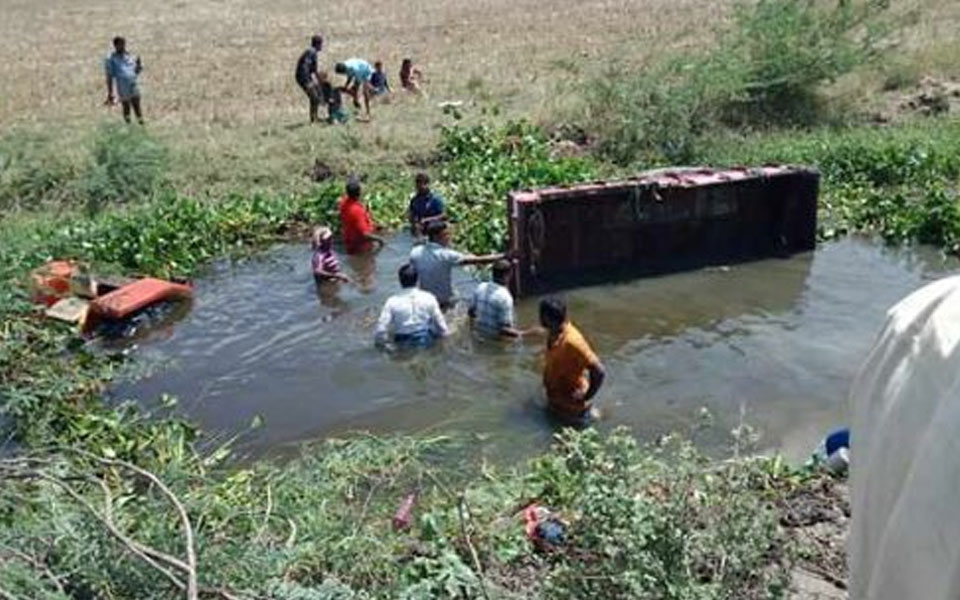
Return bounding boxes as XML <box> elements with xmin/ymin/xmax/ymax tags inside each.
<box><xmin>848</xmin><ymin>277</ymin><xmax>960</xmax><ymax>600</ymax></box>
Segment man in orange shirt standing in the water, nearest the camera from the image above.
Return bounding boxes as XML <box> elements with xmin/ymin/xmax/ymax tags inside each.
<box><xmin>540</xmin><ymin>298</ymin><xmax>606</xmax><ymax>422</ymax></box>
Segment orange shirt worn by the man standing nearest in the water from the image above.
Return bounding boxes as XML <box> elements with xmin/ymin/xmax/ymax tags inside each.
<box><xmin>543</xmin><ymin>322</ymin><xmax>600</xmax><ymax>416</ymax></box>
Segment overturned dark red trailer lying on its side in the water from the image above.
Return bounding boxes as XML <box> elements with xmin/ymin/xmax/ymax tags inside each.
<box><xmin>507</xmin><ymin>165</ymin><xmax>820</xmax><ymax>296</ymax></box>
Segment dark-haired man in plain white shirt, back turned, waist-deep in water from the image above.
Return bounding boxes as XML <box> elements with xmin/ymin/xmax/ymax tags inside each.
<box><xmin>375</xmin><ymin>264</ymin><xmax>450</xmax><ymax>347</ymax></box>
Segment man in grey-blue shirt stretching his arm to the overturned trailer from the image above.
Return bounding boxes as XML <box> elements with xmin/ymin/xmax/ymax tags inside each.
<box><xmin>410</xmin><ymin>221</ymin><xmax>503</xmax><ymax>309</ymax></box>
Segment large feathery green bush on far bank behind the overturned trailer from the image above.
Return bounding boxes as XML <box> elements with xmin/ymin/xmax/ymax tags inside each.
<box><xmin>575</xmin><ymin>0</ymin><xmax>888</xmax><ymax>164</ymax></box>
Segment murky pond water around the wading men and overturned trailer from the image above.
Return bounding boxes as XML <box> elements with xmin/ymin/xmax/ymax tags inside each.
<box><xmin>111</xmin><ymin>236</ymin><xmax>958</xmax><ymax>460</ymax></box>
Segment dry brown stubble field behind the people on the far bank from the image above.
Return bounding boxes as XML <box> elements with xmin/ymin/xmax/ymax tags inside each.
<box><xmin>0</xmin><ymin>0</ymin><xmax>960</xmax><ymax>188</ymax></box>
